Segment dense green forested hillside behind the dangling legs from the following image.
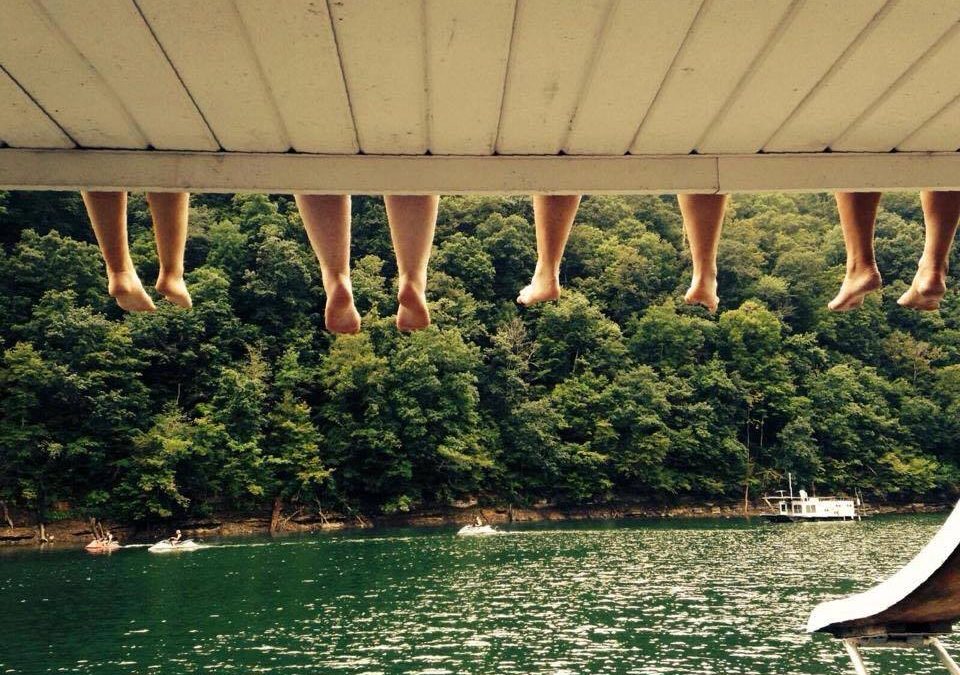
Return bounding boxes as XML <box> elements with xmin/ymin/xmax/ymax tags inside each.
<box><xmin>0</xmin><ymin>193</ymin><xmax>960</xmax><ymax>519</ymax></box>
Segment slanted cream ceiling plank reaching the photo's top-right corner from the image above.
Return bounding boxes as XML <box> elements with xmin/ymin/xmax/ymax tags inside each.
<box><xmin>764</xmin><ymin>0</ymin><xmax>960</xmax><ymax>152</ymax></box>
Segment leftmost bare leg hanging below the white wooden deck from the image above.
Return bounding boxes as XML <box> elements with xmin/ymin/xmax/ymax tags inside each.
<box><xmin>81</xmin><ymin>192</ymin><xmax>156</xmax><ymax>312</ymax></box>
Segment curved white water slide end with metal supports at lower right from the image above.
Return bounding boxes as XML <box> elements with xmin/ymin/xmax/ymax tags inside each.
<box><xmin>807</xmin><ymin>503</ymin><xmax>960</xmax><ymax>675</ymax></box>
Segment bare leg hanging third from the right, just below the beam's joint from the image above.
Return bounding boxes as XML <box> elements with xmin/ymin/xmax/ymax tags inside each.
<box><xmin>677</xmin><ymin>194</ymin><xmax>727</xmax><ymax>312</ymax></box>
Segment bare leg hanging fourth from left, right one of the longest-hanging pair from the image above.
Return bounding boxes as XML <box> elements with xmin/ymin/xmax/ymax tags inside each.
<box><xmin>384</xmin><ymin>195</ymin><xmax>440</xmax><ymax>331</ymax></box>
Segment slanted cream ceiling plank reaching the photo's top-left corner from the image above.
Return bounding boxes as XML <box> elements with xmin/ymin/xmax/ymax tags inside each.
<box><xmin>0</xmin><ymin>0</ymin><xmax>147</xmax><ymax>148</ymax></box>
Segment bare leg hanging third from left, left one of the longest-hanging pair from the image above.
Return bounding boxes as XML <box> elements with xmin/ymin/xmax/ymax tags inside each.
<box><xmin>295</xmin><ymin>195</ymin><xmax>360</xmax><ymax>333</ymax></box>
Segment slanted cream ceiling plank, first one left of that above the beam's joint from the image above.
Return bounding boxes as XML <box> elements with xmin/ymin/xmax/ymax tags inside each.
<box><xmin>630</xmin><ymin>0</ymin><xmax>790</xmax><ymax>154</ymax></box>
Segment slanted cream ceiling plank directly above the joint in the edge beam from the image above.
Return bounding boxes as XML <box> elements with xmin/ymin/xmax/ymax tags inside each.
<box><xmin>697</xmin><ymin>0</ymin><xmax>886</xmax><ymax>153</ymax></box>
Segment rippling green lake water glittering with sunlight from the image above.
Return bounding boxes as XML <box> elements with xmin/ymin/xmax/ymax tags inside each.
<box><xmin>0</xmin><ymin>516</ymin><xmax>958</xmax><ymax>675</ymax></box>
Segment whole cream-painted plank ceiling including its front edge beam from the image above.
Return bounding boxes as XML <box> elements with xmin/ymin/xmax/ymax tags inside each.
<box><xmin>0</xmin><ymin>0</ymin><xmax>960</xmax><ymax>192</ymax></box>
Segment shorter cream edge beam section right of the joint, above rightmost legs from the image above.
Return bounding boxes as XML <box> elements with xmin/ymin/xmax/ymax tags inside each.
<box><xmin>717</xmin><ymin>152</ymin><xmax>960</xmax><ymax>192</ymax></box>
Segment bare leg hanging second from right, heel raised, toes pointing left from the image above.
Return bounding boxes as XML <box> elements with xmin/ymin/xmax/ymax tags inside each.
<box><xmin>827</xmin><ymin>192</ymin><xmax>883</xmax><ymax>312</ymax></box>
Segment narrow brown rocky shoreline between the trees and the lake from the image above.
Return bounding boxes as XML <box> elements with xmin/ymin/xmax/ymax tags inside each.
<box><xmin>0</xmin><ymin>503</ymin><xmax>953</xmax><ymax>548</ymax></box>
